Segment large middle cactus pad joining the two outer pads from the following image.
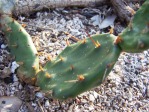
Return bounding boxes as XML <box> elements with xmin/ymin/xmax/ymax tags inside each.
<box><xmin>37</xmin><ymin>34</ymin><xmax>121</xmax><ymax>99</ymax></box>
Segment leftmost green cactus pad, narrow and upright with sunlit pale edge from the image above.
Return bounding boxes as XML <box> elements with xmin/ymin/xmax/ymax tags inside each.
<box><xmin>0</xmin><ymin>15</ymin><xmax>39</xmax><ymax>84</ymax></box>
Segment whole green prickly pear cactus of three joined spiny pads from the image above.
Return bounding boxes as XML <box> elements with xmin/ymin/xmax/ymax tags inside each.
<box><xmin>0</xmin><ymin>0</ymin><xmax>149</xmax><ymax>99</ymax></box>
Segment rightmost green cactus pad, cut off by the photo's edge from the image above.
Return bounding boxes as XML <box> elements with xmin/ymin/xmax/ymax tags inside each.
<box><xmin>119</xmin><ymin>0</ymin><xmax>149</xmax><ymax>53</ymax></box>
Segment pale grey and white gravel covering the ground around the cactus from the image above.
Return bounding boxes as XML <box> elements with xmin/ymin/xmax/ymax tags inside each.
<box><xmin>0</xmin><ymin>1</ymin><xmax>149</xmax><ymax>112</ymax></box>
